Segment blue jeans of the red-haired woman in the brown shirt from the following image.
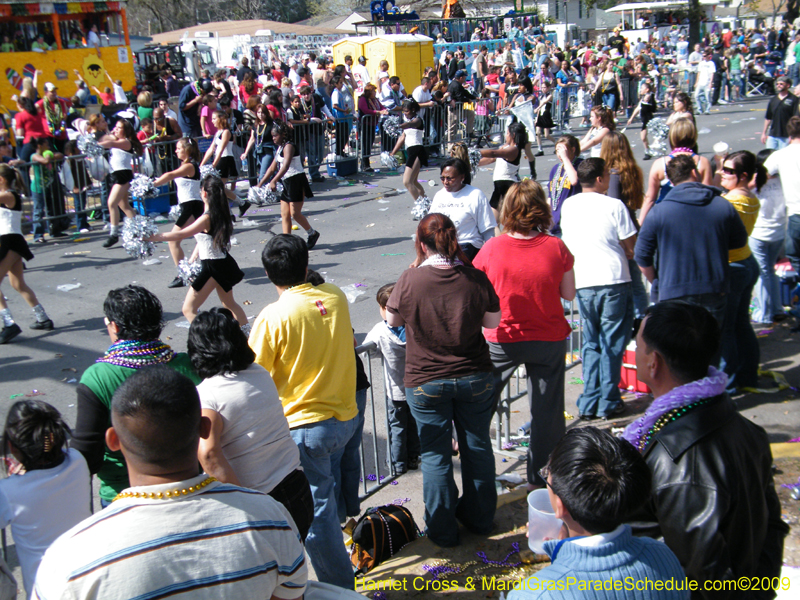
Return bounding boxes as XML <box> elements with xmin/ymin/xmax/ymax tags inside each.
<box><xmin>406</xmin><ymin>373</ymin><xmax>497</xmax><ymax>547</ymax></box>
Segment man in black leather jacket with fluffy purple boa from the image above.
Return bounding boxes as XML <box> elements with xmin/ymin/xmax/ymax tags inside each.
<box><xmin>623</xmin><ymin>301</ymin><xmax>789</xmax><ymax>600</ymax></box>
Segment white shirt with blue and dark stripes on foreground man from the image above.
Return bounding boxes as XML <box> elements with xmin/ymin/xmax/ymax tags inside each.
<box><xmin>33</xmin><ymin>474</ymin><xmax>308</xmax><ymax>600</ymax></box>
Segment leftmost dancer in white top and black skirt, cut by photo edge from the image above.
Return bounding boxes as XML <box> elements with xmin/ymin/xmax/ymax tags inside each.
<box><xmin>0</xmin><ymin>165</ymin><xmax>53</xmax><ymax>344</ymax></box>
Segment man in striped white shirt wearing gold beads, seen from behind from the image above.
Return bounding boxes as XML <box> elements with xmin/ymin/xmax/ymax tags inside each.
<box><xmin>32</xmin><ymin>365</ymin><xmax>308</xmax><ymax>600</ymax></box>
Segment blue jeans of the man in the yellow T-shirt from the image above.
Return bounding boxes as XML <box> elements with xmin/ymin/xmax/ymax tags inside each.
<box><xmin>291</xmin><ymin>417</ymin><xmax>358</xmax><ymax>590</ymax></box>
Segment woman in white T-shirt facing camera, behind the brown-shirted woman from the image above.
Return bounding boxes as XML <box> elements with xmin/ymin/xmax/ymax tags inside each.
<box><xmin>424</xmin><ymin>158</ymin><xmax>497</xmax><ymax>266</ymax></box>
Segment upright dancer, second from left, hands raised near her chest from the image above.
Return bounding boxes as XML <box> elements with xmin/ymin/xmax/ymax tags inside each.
<box><xmin>98</xmin><ymin>119</ymin><xmax>142</xmax><ymax>248</ymax></box>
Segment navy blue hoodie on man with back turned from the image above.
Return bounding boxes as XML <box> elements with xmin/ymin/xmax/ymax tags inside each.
<box><xmin>634</xmin><ymin>182</ymin><xmax>747</xmax><ymax>300</ymax></box>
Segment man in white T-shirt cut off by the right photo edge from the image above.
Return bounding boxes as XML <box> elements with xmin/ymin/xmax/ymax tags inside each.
<box><xmin>764</xmin><ymin>117</ymin><xmax>800</xmax><ymax>273</ymax></box>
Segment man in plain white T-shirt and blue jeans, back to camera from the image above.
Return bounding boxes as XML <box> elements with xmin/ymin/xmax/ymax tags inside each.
<box><xmin>561</xmin><ymin>158</ymin><xmax>636</xmax><ymax>420</ymax></box>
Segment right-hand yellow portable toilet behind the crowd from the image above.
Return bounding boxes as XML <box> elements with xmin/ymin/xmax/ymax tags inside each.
<box><xmin>364</xmin><ymin>33</ymin><xmax>435</xmax><ymax>90</ymax></box>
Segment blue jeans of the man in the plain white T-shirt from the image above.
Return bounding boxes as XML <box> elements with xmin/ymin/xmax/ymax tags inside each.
<box><xmin>577</xmin><ymin>283</ymin><xmax>633</xmax><ymax>417</ymax></box>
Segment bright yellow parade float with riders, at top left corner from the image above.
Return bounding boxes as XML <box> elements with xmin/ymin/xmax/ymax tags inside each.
<box><xmin>0</xmin><ymin>0</ymin><xmax>135</xmax><ymax>101</ymax></box>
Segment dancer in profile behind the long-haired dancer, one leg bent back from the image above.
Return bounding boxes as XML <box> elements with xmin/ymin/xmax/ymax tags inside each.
<box><xmin>153</xmin><ymin>138</ymin><xmax>205</xmax><ymax>288</ymax></box>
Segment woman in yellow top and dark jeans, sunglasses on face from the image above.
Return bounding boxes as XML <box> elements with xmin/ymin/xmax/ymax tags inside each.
<box><xmin>718</xmin><ymin>150</ymin><xmax>768</xmax><ymax>394</ymax></box>
